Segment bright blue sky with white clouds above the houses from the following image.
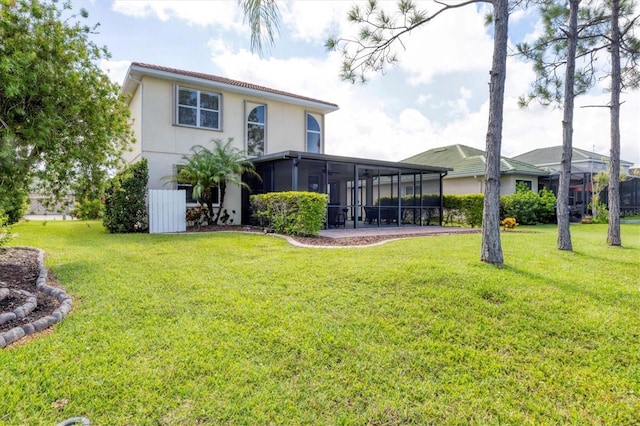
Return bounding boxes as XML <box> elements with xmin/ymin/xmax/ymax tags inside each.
<box><xmin>73</xmin><ymin>0</ymin><xmax>640</xmax><ymax>166</ymax></box>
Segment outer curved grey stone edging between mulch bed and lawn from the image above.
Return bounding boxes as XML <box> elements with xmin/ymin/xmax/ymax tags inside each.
<box><xmin>0</xmin><ymin>247</ymin><xmax>73</xmax><ymax>349</ymax></box>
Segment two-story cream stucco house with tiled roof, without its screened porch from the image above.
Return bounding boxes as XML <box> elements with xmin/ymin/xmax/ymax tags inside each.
<box><xmin>122</xmin><ymin>62</ymin><xmax>338</xmax><ymax>223</ymax></box>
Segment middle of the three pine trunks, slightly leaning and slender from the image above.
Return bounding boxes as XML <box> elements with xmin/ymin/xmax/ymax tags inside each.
<box><xmin>556</xmin><ymin>0</ymin><xmax>580</xmax><ymax>251</ymax></box>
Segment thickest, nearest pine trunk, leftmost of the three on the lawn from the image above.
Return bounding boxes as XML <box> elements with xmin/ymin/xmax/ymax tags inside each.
<box><xmin>480</xmin><ymin>0</ymin><xmax>509</xmax><ymax>266</ymax></box>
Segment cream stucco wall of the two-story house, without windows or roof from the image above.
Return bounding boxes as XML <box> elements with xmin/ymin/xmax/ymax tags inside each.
<box><xmin>130</xmin><ymin>76</ymin><xmax>324</xmax><ymax>224</ymax></box>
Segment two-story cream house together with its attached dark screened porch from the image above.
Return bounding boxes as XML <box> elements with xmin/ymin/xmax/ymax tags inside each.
<box><xmin>122</xmin><ymin>62</ymin><xmax>448</xmax><ymax>227</ymax></box>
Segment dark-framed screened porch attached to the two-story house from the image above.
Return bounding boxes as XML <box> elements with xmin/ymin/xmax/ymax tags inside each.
<box><xmin>242</xmin><ymin>151</ymin><xmax>451</xmax><ymax>228</ymax></box>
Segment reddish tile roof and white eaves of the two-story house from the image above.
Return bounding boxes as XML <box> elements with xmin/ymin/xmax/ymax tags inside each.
<box><xmin>122</xmin><ymin>62</ymin><xmax>338</xmax><ymax>112</ymax></box>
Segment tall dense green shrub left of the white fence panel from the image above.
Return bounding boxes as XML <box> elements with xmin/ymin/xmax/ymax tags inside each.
<box><xmin>102</xmin><ymin>159</ymin><xmax>149</xmax><ymax>234</ymax></box>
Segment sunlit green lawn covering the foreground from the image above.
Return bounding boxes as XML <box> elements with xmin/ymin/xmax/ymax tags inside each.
<box><xmin>0</xmin><ymin>221</ymin><xmax>640</xmax><ymax>425</ymax></box>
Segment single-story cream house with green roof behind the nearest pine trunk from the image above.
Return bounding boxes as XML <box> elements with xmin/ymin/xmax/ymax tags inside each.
<box><xmin>402</xmin><ymin>144</ymin><xmax>549</xmax><ymax>195</ymax></box>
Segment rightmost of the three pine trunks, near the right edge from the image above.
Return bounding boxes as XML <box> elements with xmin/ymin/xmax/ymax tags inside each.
<box><xmin>607</xmin><ymin>0</ymin><xmax>622</xmax><ymax>246</ymax></box>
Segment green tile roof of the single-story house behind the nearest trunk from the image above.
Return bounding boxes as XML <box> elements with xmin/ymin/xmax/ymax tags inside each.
<box><xmin>402</xmin><ymin>144</ymin><xmax>549</xmax><ymax>177</ymax></box>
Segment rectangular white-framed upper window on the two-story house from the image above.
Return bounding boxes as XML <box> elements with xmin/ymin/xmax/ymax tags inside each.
<box><xmin>176</xmin><ymin>87</ymin><xmax>220</xmax><ymax>130</ymax></box>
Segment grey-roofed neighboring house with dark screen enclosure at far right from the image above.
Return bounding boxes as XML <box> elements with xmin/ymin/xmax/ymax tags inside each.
<box><xmin>513</xmin><ymin>146</ymin><xmax>640</xmax><ymax>217</ymax></box>
